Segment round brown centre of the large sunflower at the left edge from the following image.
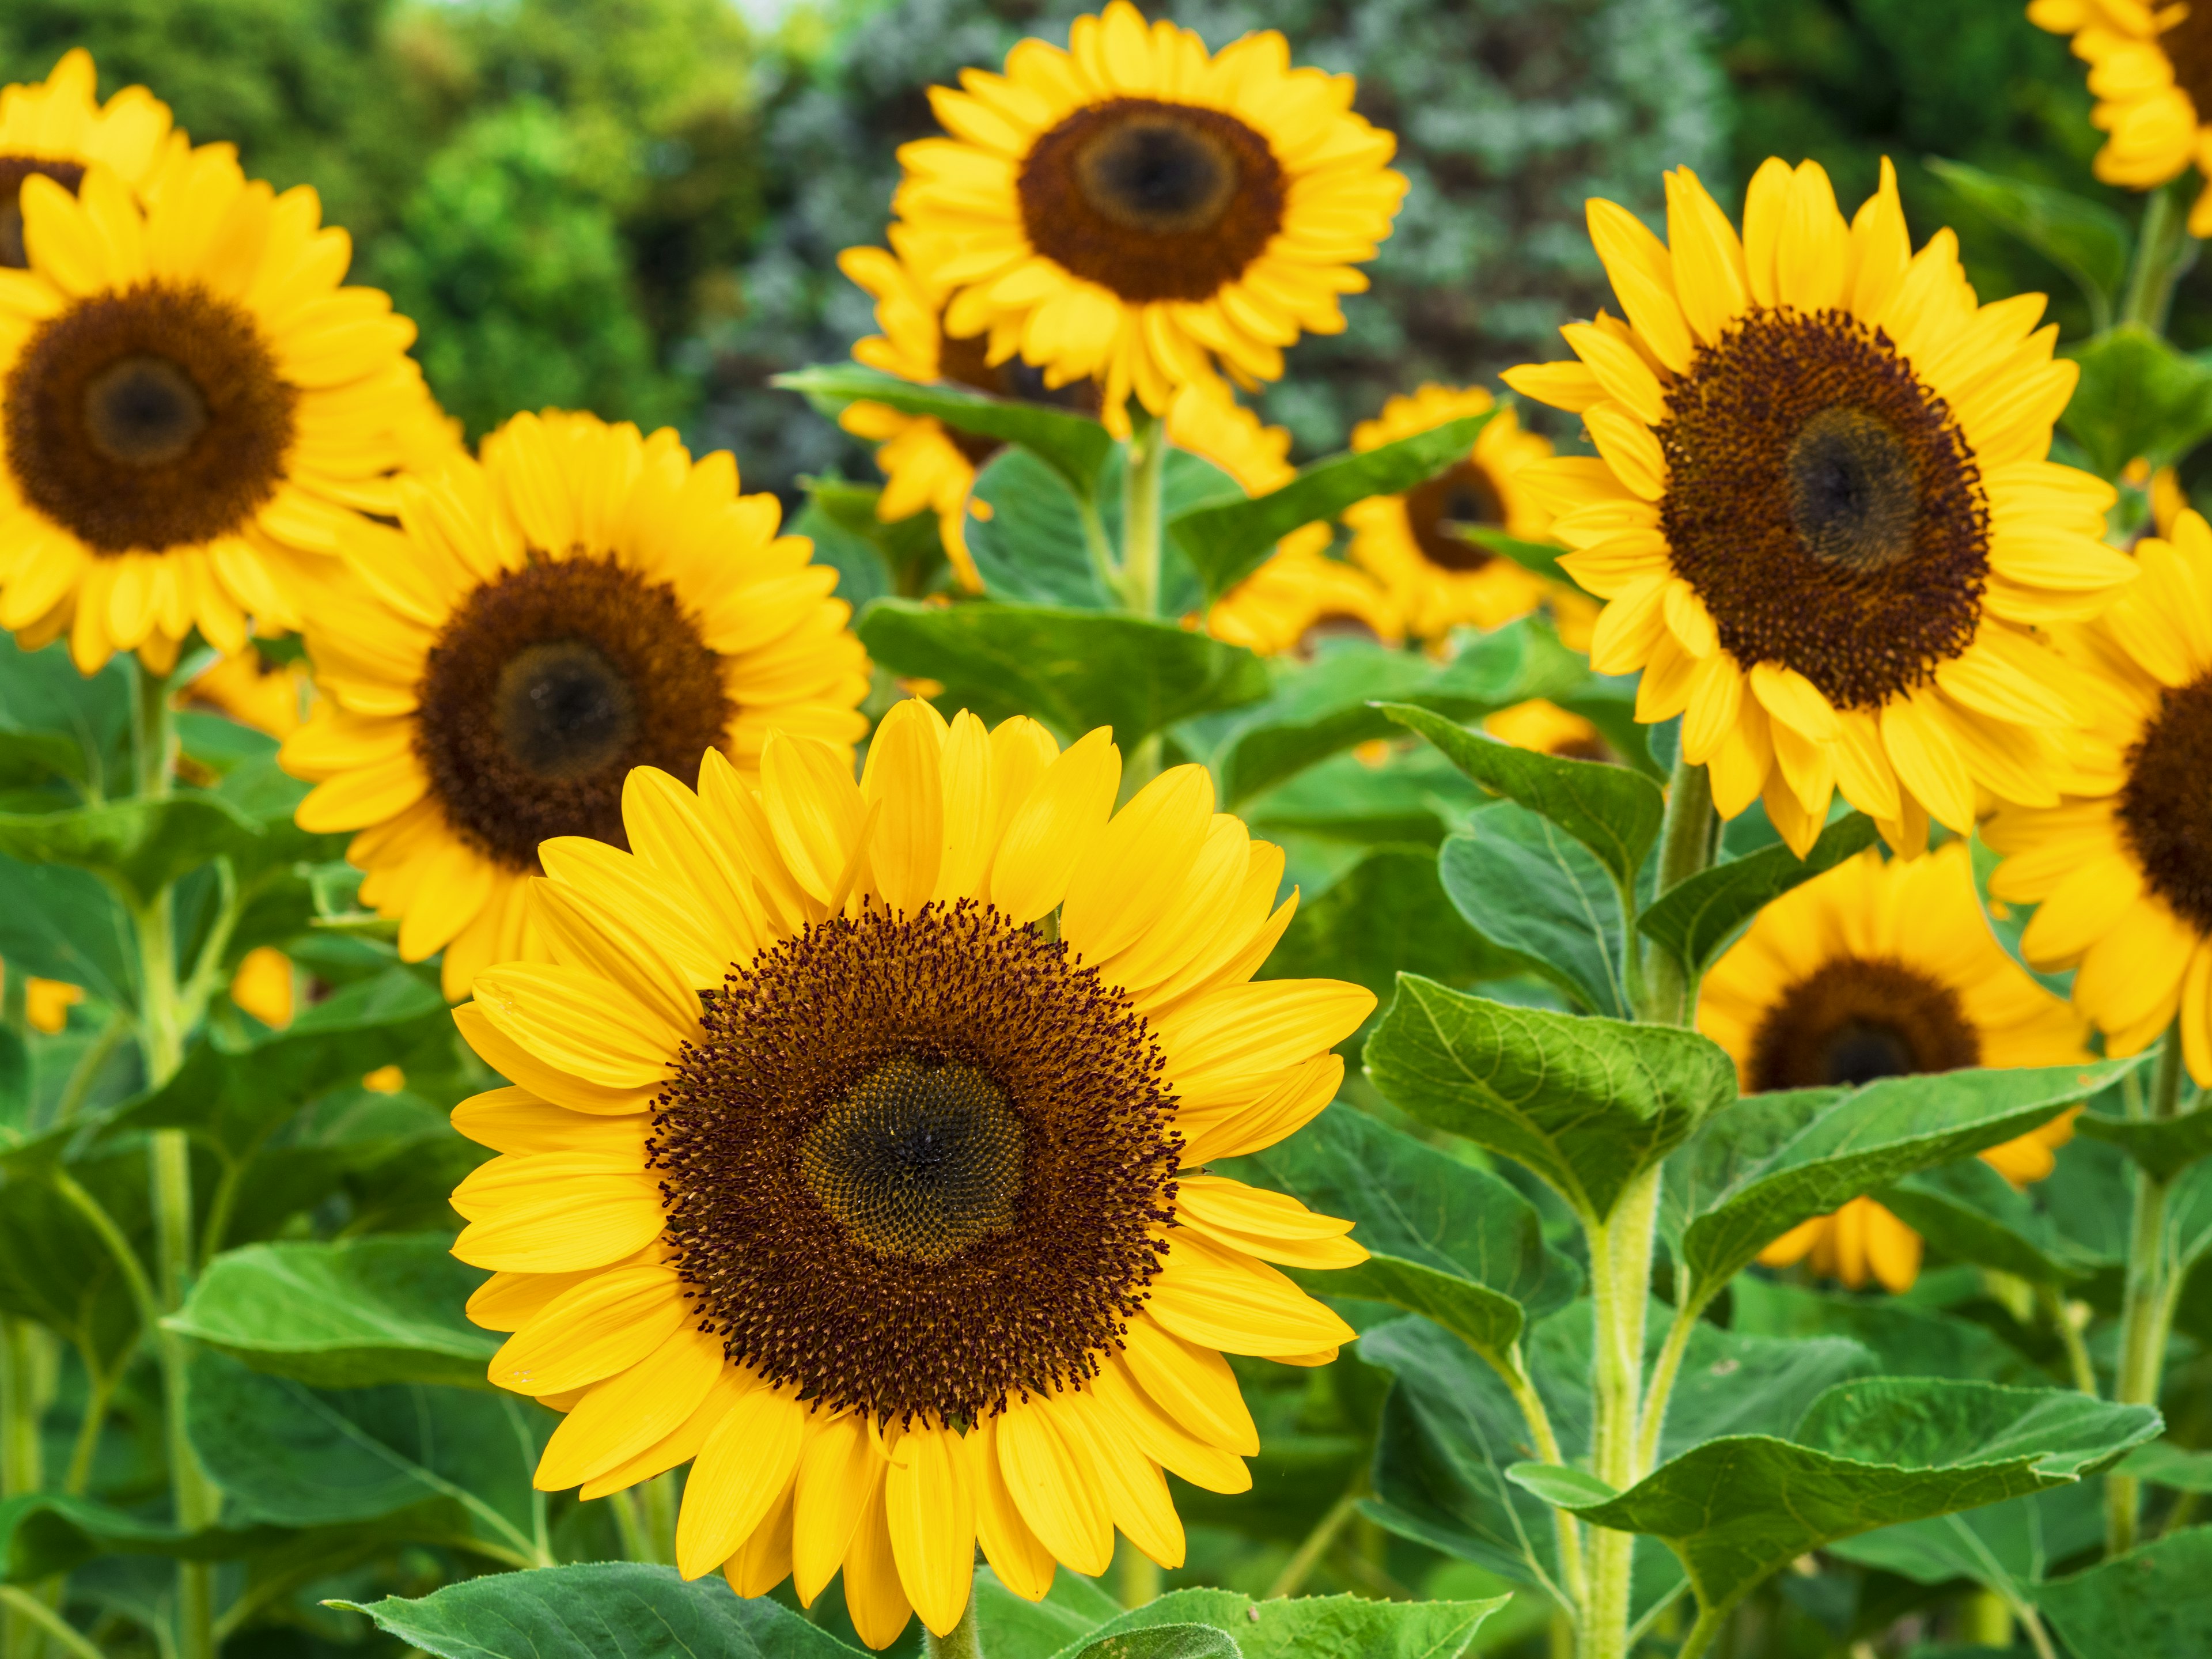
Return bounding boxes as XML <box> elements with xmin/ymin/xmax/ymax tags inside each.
<box><xmin>0</xmin><ymin>281</ymin><xmax>298</xmax><ymax>553</ymax></box>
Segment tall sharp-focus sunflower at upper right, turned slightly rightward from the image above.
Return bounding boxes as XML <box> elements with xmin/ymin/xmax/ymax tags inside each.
<box><xmin>1506</xmin><ymin>159</ymin><xmax>2135</xmax><ymax>851</ymax></box>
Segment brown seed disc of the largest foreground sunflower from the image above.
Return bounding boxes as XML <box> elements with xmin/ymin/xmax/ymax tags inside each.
<box><xmin>653</xmin><ymin>900</ymin><xmax>1181</xmax><ymax>1422</ymax></box>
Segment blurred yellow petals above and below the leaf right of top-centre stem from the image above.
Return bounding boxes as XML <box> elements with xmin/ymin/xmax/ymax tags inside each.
<box><xmin>1168</xmin><ymin>387</ymin><xmax>1404</xmax><ymax>657</ymax></box>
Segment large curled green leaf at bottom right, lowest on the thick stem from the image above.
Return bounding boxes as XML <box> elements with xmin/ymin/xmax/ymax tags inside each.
<box><xmin>1539</xmin><ymin>1376</ymin><xmax>2159</xmax><ymax>1611</ymax></box>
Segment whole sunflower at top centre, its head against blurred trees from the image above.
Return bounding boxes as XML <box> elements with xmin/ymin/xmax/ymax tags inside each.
<box><xmin>892</xmin><ymin>0</ymin><xmax>1404</xmax><ymax>434</ymax></box>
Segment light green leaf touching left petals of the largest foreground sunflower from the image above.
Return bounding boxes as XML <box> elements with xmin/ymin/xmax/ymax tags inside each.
<box><xmin>161</xmin><ymin>1234</ymin><xmax>500</xmax><ymax>1389</ymax></box>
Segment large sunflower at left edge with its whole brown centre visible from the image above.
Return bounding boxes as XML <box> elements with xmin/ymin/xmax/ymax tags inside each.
<box><xmin>0</xmin><ymin>146</ymin><xmax>425</xmax><ymax>672</ymax></box>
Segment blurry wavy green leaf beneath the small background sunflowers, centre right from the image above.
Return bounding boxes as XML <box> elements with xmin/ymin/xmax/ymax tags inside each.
<box><xmin>1214</xmin><ymin>617</ymin><xmax>1593</xmax><ymax>808</ymax></box>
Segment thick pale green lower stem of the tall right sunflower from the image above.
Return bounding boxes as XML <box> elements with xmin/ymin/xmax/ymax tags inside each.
<box><xmin>1582</xmin><ymin>1166</ymin><xmax>1659</xmax><ymax>1659</ymax></box>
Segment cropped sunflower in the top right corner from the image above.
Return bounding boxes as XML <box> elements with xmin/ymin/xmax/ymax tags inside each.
<box><xmin>2028</xmin><ymin>0</ymin><xmax>2212</xmax><ymax>237</ymax></box>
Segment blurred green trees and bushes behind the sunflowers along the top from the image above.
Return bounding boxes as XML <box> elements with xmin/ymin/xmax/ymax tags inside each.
<box><xmin>0</xmin><ymin>0</ymin><xmax>2168</xmax><ymax>491</ymax></box>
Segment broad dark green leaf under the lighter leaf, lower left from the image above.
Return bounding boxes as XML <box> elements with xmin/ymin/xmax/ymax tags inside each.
<box><xmin>186</xmin><ymin>1351</ymin><xmax>553</xmax><ymax>1566</ymax></box>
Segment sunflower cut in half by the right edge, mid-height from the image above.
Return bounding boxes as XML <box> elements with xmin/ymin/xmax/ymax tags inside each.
<box><xmin>1984</xmin><ymin>509</ymin><xmax>2212</xmax><ymax>1084</ymax></box>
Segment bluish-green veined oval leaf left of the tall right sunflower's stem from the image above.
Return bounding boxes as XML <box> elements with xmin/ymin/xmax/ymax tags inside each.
<box><xmin>1435</xmin><ymin>809</ymin><xmax>1633</xmax><ymax>1020</ymax></box>
